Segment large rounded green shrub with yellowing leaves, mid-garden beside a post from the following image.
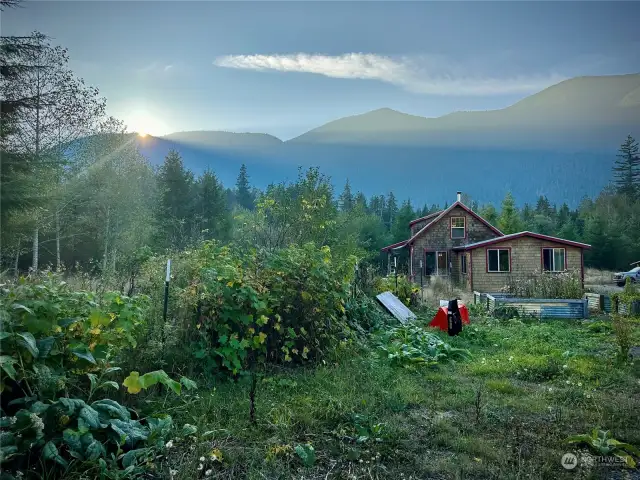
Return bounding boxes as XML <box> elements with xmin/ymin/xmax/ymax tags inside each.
<box><xmin>140</xmin><ymin>242</ymin><xmax>355</xmax><ymax>376</ymax></box>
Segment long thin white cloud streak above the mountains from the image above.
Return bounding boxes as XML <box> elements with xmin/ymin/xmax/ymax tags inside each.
<box><xmin>214</xmin><ymin>53</ymin><xmax>567</xmax><ymax>95</ymax></box>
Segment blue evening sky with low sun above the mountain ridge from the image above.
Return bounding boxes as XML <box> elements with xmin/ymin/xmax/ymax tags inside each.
<box><xmin>0</xmin><ymin>0</ymin><xmax>640</xmax><ymax>140</ymax></box>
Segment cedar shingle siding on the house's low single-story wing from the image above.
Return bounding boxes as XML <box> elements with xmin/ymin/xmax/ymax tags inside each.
<box><xmin>469</xmin><ymin>237</ymin><xmax>582</xmax><ymax>293</ymax></box>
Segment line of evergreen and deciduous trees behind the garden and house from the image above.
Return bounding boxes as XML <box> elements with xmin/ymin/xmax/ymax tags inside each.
<box><xmin>0</xmin><ymin>33</ymin><xmax>640</xmax><ymax>277</ymax></box>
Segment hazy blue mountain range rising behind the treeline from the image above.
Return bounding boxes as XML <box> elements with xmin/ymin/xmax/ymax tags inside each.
<box><xmin>132</xmin><ymin>74</ymin><xmax>640</xmax><ymax>206</ymax></box>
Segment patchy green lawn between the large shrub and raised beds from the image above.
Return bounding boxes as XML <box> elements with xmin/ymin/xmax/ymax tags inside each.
<box><xmin>147</xmin><ymin>318</ymin><xmax>640</xmax><ymax>480</ymax></box>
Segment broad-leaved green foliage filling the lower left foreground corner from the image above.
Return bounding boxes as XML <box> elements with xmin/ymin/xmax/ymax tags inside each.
<box><xmin>0</xmin><ymin>276</ymin><xmax>195</xmax><ymax>478</ymax></box>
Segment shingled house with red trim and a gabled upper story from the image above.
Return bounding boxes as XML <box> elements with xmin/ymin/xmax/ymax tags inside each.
<box><xmin>382</xmin><ymin>192</ymin><xmax>591</xmax><ymax>292</ymax></box>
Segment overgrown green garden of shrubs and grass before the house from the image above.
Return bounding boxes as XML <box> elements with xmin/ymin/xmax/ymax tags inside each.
<box><xmin>0</xmin><ymin>241</ymin><xmax>640</xmax><ymax>480</ymax></box>
